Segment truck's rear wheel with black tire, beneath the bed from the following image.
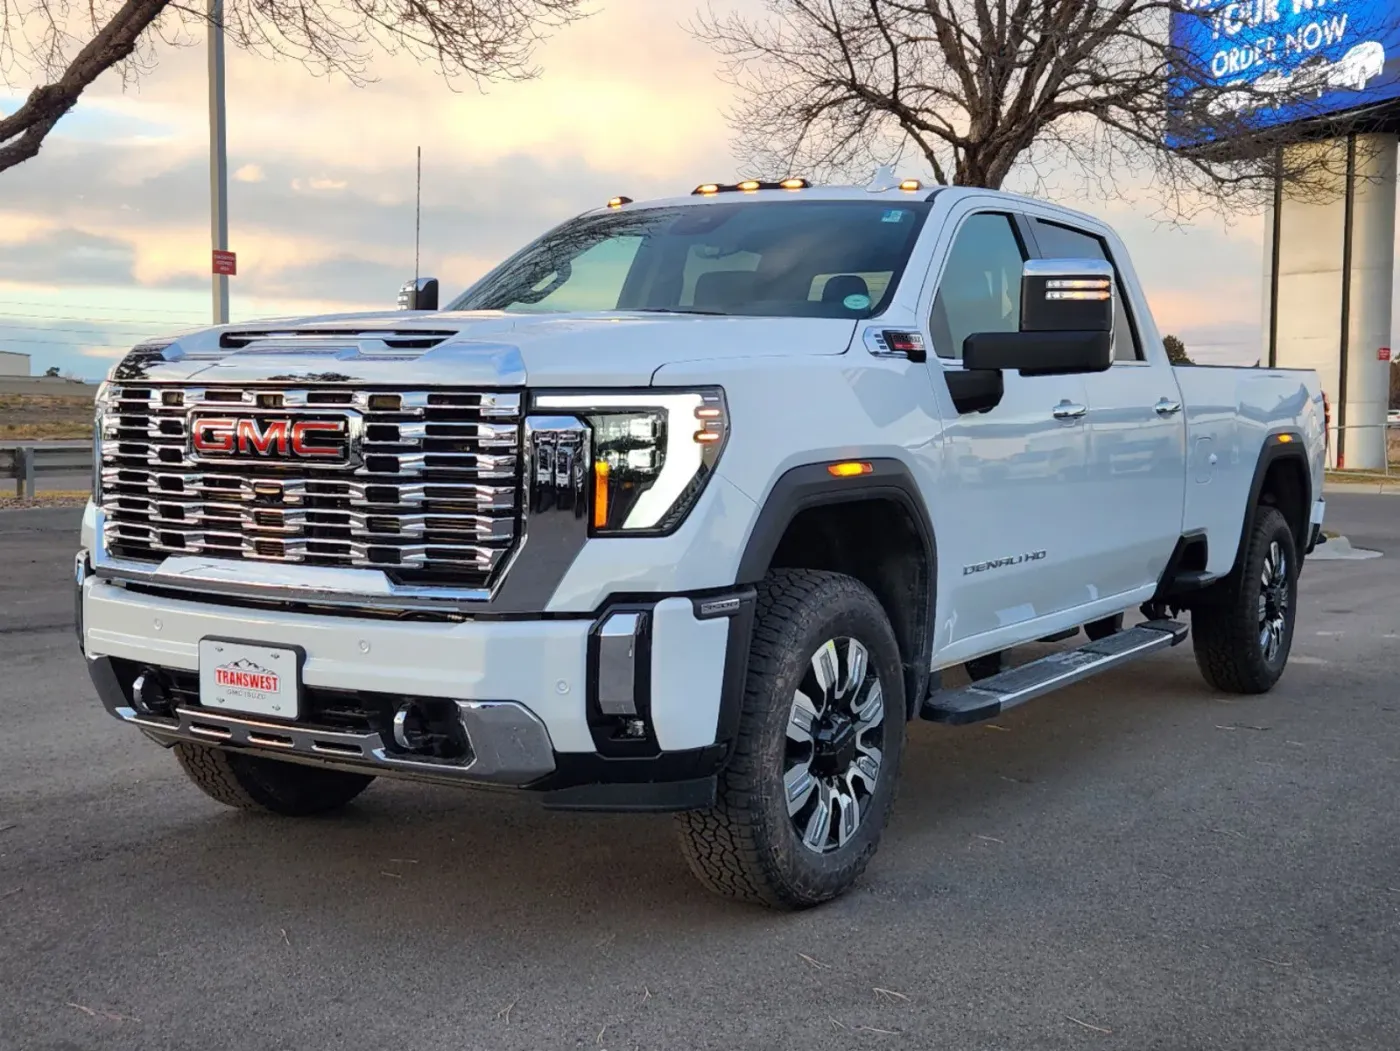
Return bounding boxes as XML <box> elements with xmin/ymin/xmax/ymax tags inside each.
<box><xmin>1191</xmin><ymin>507</ymin><xmax>1298</xmax><ymax>694</ymax></box>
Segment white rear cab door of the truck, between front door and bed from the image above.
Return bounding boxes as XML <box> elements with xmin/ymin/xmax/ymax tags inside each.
<box><xmin>1030</xmin><ymin>217</ymin><xmax>1186</xmax><ymax>599</ymax></box>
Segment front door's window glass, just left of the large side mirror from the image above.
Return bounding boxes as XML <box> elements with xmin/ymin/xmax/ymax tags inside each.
<box><xmin>930</xmin><ymin>211</ymin><xmax>1026</xmax><ymax>360</ymax></box>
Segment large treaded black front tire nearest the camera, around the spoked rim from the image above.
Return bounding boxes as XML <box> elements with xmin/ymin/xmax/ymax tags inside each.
<box><xmin>676</xmin><ymin>570</ymin><xmax>909</xmax><ymax>908</ymax></box>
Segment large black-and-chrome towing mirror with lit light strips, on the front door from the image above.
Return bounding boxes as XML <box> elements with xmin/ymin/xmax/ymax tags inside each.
<box><xmin>963</xmin><ymin>259</ymin><xmax>1117</xmax><ymax>376</ymax></box>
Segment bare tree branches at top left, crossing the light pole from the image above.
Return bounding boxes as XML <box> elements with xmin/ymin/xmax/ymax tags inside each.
<box><xmin>0</xmin><ymin>0</ymin><xmax>582</xmax><ymax>172</ymax></box>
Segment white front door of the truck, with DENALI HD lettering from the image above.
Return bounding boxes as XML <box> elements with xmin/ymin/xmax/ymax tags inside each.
<box><xmin>930</xmin><ymin>204</ymin><xmax>1099</xmax><ymax>661</ymax></box>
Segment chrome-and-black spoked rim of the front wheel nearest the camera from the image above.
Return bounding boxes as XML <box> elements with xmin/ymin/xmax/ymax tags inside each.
<box><xmin>783</xmin><ymin>637</ymin><xmax>885</xmax><ymax>854</ymax></box>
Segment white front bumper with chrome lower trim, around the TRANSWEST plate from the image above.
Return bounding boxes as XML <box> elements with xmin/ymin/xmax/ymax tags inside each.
<box><xmin>76</xmin><ymin>570</ymin><xmax>753</xmax><ymax>810</ymax></box>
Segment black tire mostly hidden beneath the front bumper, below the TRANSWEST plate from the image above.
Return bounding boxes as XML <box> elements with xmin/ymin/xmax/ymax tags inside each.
<box><xmin>175</xmin><ymin>742</ymin><xmax>374</xmax><ymax>817</ymax></box>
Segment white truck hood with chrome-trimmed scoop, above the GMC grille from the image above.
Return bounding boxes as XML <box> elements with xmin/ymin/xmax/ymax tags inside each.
<box><xmin>112</xmin><ymin>311</ymin><xmax>855</xmax><ymax>386</ymax></box>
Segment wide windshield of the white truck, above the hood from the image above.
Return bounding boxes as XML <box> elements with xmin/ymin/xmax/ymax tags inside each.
<box><xmin>448</xmin><ymin>200</ymin><xmax>928</xmax><ymax>319</ymax></box>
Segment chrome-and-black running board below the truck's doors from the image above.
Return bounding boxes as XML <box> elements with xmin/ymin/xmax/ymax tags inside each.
<box><xmin>920</xmin><ymin>620</ymin><xmax>1189</xmax><ymax>726</ymax></box>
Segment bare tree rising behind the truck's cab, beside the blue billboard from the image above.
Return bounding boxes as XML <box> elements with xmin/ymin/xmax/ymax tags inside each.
<box><xmin>692</xmin><ymin>0</ymin><xmax>1377</xmax><ymax>217</ymax></box>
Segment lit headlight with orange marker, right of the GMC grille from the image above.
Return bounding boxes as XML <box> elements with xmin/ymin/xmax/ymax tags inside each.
<box><xmin>535</xmin><ymin>388</ymin><xmax>728</xmax><ymax>536</ymax></box>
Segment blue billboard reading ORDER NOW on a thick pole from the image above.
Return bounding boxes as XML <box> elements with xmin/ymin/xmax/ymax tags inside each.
<box><xmin>1168</xmin><ymin>0</ymin><xmax>1400</xmax><ymax>146</ymax></box>
